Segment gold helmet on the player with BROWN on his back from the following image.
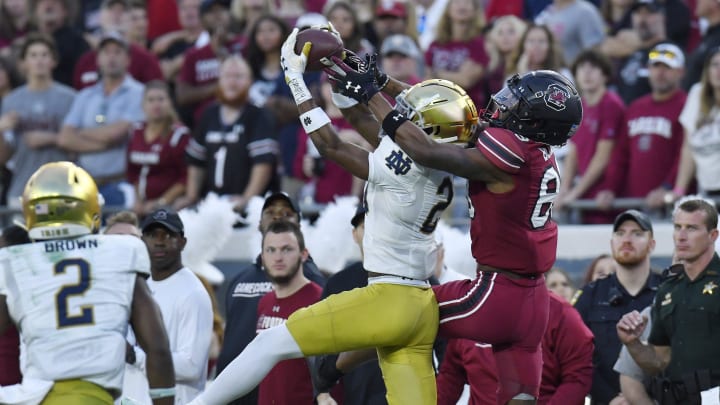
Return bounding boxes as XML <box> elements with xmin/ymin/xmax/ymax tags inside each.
<box><xmin>22</xmin><ymin>162</ymin><xmax>102</xmax><ymax>240</ymax></box>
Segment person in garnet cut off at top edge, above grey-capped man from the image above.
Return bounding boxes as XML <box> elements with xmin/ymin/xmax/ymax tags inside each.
<box><xmin>368</xmin><ymin>0</ymin><xmax>417</xmax><ymax>48</ymax></box>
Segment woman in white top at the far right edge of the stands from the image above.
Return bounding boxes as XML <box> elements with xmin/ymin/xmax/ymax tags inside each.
<box><xmin>665</xmin><ymin>47</ymin><xmax>720</xmax><ymax>202</ymax></box>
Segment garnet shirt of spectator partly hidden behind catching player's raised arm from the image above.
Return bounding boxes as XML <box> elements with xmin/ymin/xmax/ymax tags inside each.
<box><xmin>293</xmin><ymin>117</ymin><xmax>353</xmax><ymax>204</ymax></box>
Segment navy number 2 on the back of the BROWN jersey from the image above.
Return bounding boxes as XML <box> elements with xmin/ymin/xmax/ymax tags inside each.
<box><xmin>55</xmin><ymin>259</ymin><xmax>95</xmax><ymax>328</ymax></box>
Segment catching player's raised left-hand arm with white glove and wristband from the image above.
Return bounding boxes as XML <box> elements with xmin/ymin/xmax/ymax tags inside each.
<box><xmin>280</xmin><ymin>28</ymin><xmax>369</xmax><ymax>180</ymax></box>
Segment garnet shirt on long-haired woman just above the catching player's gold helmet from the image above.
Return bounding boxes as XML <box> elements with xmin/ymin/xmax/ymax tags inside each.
<box><xmin>425</xmin><ymin>36</ymin><xmax>490</xmax><ymax>108</ymax></box>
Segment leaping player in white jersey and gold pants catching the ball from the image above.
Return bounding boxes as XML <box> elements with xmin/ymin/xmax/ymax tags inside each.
<box><xmin>192</xmin><ymin>29</ymin><xmax>478</xmax><ymax>405</ymax></box>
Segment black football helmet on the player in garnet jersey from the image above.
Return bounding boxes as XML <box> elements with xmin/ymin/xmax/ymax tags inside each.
<box><xmin>483</xmin><ymin>70</ymin><xmax>582</xmax><ymax>146</ymax></box>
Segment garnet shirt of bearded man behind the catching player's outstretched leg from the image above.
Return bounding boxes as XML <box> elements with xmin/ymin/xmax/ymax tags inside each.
<box><xmin>257</xmin><ymin>282</ymin><xmax>322</xmax><ymax>405</ymax></box>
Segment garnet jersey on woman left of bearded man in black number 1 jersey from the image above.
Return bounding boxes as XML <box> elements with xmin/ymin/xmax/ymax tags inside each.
<box><xmin>127</xmin><ymin>123</ymin><xmax>190</xmax><ymax>200</ymax></box>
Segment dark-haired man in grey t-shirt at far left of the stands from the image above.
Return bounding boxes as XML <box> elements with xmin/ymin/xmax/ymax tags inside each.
<box><xmin>0</xmin><ymin>33</ymin><xmax>75</xmax><ymax>207</ymax></box>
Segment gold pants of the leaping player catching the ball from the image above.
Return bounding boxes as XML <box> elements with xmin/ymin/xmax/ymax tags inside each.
<box><xmin>286</xmin><ymin>283</ymin><xmax>438</xmax><ymax>405</ymax></box>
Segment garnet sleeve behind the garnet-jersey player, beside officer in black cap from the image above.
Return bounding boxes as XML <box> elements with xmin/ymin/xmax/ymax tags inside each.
<box><xmin>549</xmin><ymin>305</ymin><xmax>595</xmax><ymax>405</ymax></box>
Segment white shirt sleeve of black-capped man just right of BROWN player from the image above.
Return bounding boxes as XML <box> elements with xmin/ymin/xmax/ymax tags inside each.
<box><xmin>172</xmin><ymin>290</ymin><xmax>212</xmax><ymax>383</ymax></box>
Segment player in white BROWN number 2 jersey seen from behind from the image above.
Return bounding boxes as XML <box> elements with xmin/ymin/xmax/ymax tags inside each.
<box><xmin>0</xmin><ymin>162</ymin><xmax>175</xmax><ymax>405</ymax></box>
